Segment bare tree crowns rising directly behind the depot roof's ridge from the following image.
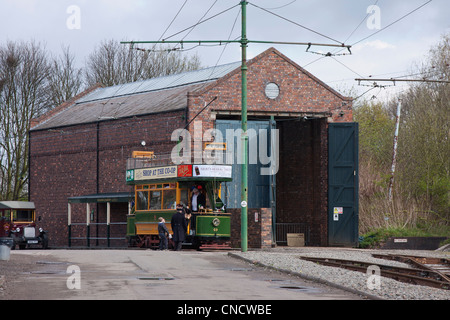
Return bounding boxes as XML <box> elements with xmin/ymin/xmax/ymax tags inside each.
<box><xmin>85</xmin><ymin>40</ymin><xmax>200</xmax><ymax>86</ymax></box>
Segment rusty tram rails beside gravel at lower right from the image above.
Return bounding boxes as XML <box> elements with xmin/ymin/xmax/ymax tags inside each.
<box><xmin>300</xmin><ymin>257</ymin><xmax>450</xmax><ymax>290</ymax></box>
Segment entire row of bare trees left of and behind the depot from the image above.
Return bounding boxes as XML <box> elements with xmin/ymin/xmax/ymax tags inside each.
<box><xmin>0</xmin><ymin>40</ymin><xmax>200</xmax><ymax>200</ymax></box>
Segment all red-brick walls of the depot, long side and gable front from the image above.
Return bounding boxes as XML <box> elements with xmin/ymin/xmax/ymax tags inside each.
<box><xmin>30</xmin><ymin>49</ymin><xmax>352</xmax><ymax>246</ymax></box>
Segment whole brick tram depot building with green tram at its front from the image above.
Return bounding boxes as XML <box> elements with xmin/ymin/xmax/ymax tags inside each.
<box><xmin>29</xmin><ymin>48</ymin><xmax>358</xmax><ymax>248</ymax></box>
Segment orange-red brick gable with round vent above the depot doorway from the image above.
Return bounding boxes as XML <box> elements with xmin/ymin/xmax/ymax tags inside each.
<box><xmin>188</xmin><ymin>49</ymin><xmax>352</xmax><ymax>139</ymax></box>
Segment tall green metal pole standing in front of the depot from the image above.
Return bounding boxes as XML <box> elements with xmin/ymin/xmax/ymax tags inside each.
<box><xmin>241</xmin><ymin>1</ymin><xmax>248</xmax><ymax>252</ymax></box>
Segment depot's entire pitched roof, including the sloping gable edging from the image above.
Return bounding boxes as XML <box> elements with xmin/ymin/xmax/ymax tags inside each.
<box><xmin>30</xmin><ymin>48</ymin><xmax>351</xmax><ymax>131</ymax></box>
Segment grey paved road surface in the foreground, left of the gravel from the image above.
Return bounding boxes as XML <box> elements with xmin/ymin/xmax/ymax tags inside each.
<box><xmin>0</xmin><ymin>250</ymin><xmax>362</xmax><ymax>300</ymax></box>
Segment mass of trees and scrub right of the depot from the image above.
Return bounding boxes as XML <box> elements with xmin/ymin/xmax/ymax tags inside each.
<box><xmin>354</xmin><ymin>34</ymin><xmax>450</xmax><ymax>231</ymax></box>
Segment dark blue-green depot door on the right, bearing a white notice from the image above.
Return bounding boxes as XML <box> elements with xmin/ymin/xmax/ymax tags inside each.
<box><xmin>328</xmin><ymin>123</ymin><xmax>358</xmax><ymax>246</ymax></box>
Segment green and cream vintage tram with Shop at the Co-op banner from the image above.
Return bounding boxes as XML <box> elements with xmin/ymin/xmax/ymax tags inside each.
<box><xmin>127</xmin><ymin>158</ymin><xmax>232</xmax><ymax>249</ymax></box>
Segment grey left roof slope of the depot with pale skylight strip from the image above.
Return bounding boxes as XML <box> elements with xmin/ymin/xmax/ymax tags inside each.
<box><xmin>31</xmin><ymin>62</ymin><xmax>240</xmax><ymax>131</ymax></box>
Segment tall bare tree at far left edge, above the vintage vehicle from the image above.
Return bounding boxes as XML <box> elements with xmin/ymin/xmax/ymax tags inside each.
<box><xmin>0</xmin><ymin>42</ymin><xmax>50</xmax><ymax>200</ymax></box>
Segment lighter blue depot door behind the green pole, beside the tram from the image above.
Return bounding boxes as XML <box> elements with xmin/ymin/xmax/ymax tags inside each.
<box><xmin>216</xmin><ymin>120</ymin><xmax>271</xmax><ymax>208</ymax></box>
